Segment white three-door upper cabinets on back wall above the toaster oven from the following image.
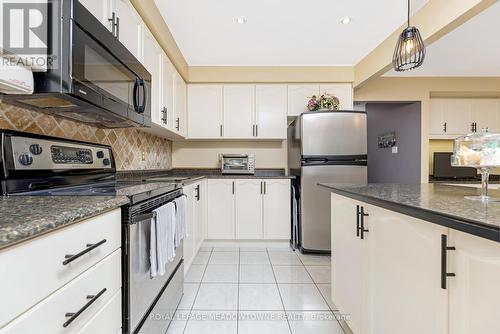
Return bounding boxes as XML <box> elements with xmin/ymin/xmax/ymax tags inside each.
<box><xmin>188</xmin><ymin>84</ymin><xmax>287</xmax><ymax>140</ymax></box>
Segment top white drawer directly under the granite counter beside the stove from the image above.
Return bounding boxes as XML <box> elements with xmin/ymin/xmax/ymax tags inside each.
<box><xmin>0</xmin><ymin>209</ymin><xmax>121</xmax><ymax>328</ymax></box>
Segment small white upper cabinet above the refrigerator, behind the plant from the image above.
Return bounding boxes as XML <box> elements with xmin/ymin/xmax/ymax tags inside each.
<box><xmin>288</xmin><ymin>83</ymin><xmax>353</xmax><ymax>116</ymax></box>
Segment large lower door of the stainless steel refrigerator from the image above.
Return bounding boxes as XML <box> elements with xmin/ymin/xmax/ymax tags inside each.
<box><xmin>300</xmin><ymin>165</ymin><xmax>368</xmax><ymax>252</ymax></box>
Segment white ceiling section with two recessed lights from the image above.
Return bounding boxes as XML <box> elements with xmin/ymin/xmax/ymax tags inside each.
<box><xmin>155</xmin><ymin>0</ymin><xmax>428</xmax><ymax>66</ymax></box>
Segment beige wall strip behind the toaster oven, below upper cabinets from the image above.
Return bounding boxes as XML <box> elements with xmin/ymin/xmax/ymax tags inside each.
<box><xmin>172</xmin><ymin>141</ymin><xmax>287</xmax><ymax>168</ymax></box>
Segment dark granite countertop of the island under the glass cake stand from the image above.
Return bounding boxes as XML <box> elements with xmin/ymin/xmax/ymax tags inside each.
<box><xmin>320</xmin><ymin>183</ymin><xmax>500</xmax><ymax>242</ymax></box>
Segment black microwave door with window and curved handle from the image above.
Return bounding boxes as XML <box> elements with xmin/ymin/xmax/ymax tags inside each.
<box><xmin>71</xmin><ymin>22</ymin><xmax>149</xmax><ymax>125</ymax></box>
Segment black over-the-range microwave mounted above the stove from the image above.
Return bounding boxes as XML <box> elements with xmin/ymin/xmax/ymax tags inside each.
<box><xmin>4</xmin><ymin>0</ymin><xmax>151</xmax><ymax>128</ymax></box>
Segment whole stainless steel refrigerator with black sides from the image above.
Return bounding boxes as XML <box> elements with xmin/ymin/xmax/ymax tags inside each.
<box><xmin>288</xmin><ymin>111</ymin><xmax>367</xmax><ymax>253</ymax></box>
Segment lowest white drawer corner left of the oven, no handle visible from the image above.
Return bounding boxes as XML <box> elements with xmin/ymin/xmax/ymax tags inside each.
<box><xmin>78</xmin><ymin>289</ymin><xmax>122</xmax><ymax>334</ymax></box>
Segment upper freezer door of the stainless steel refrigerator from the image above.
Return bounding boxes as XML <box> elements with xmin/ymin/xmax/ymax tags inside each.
<box><xmin>301</xmin><ymin>111</ymin><xmax>367</xmax><ymax>156</ymax></box>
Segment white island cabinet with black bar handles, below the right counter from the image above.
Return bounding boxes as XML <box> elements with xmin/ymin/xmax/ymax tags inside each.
<box><xmin>332</xmin><ymin>194</ymin><xmax>500</xmax><ymax>334</ymax></box>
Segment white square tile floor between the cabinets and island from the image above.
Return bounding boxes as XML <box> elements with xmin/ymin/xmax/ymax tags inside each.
<box><xmin>167</xmin><ymin>247</ymin><xmax>343</xmax><ymax>334</ymax></box>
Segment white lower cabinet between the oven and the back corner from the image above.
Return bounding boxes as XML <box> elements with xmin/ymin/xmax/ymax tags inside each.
<box><xmin>183</xmin><ymin>180</ymin><xmax>206</xmax><ymax>272</ymax></box>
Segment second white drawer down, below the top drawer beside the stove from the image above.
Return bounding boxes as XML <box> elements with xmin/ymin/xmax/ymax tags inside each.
<box><xmin>2</xmin><ymin>250</ymin><xmax>121</xmax><ymax>334</ymax></box>
